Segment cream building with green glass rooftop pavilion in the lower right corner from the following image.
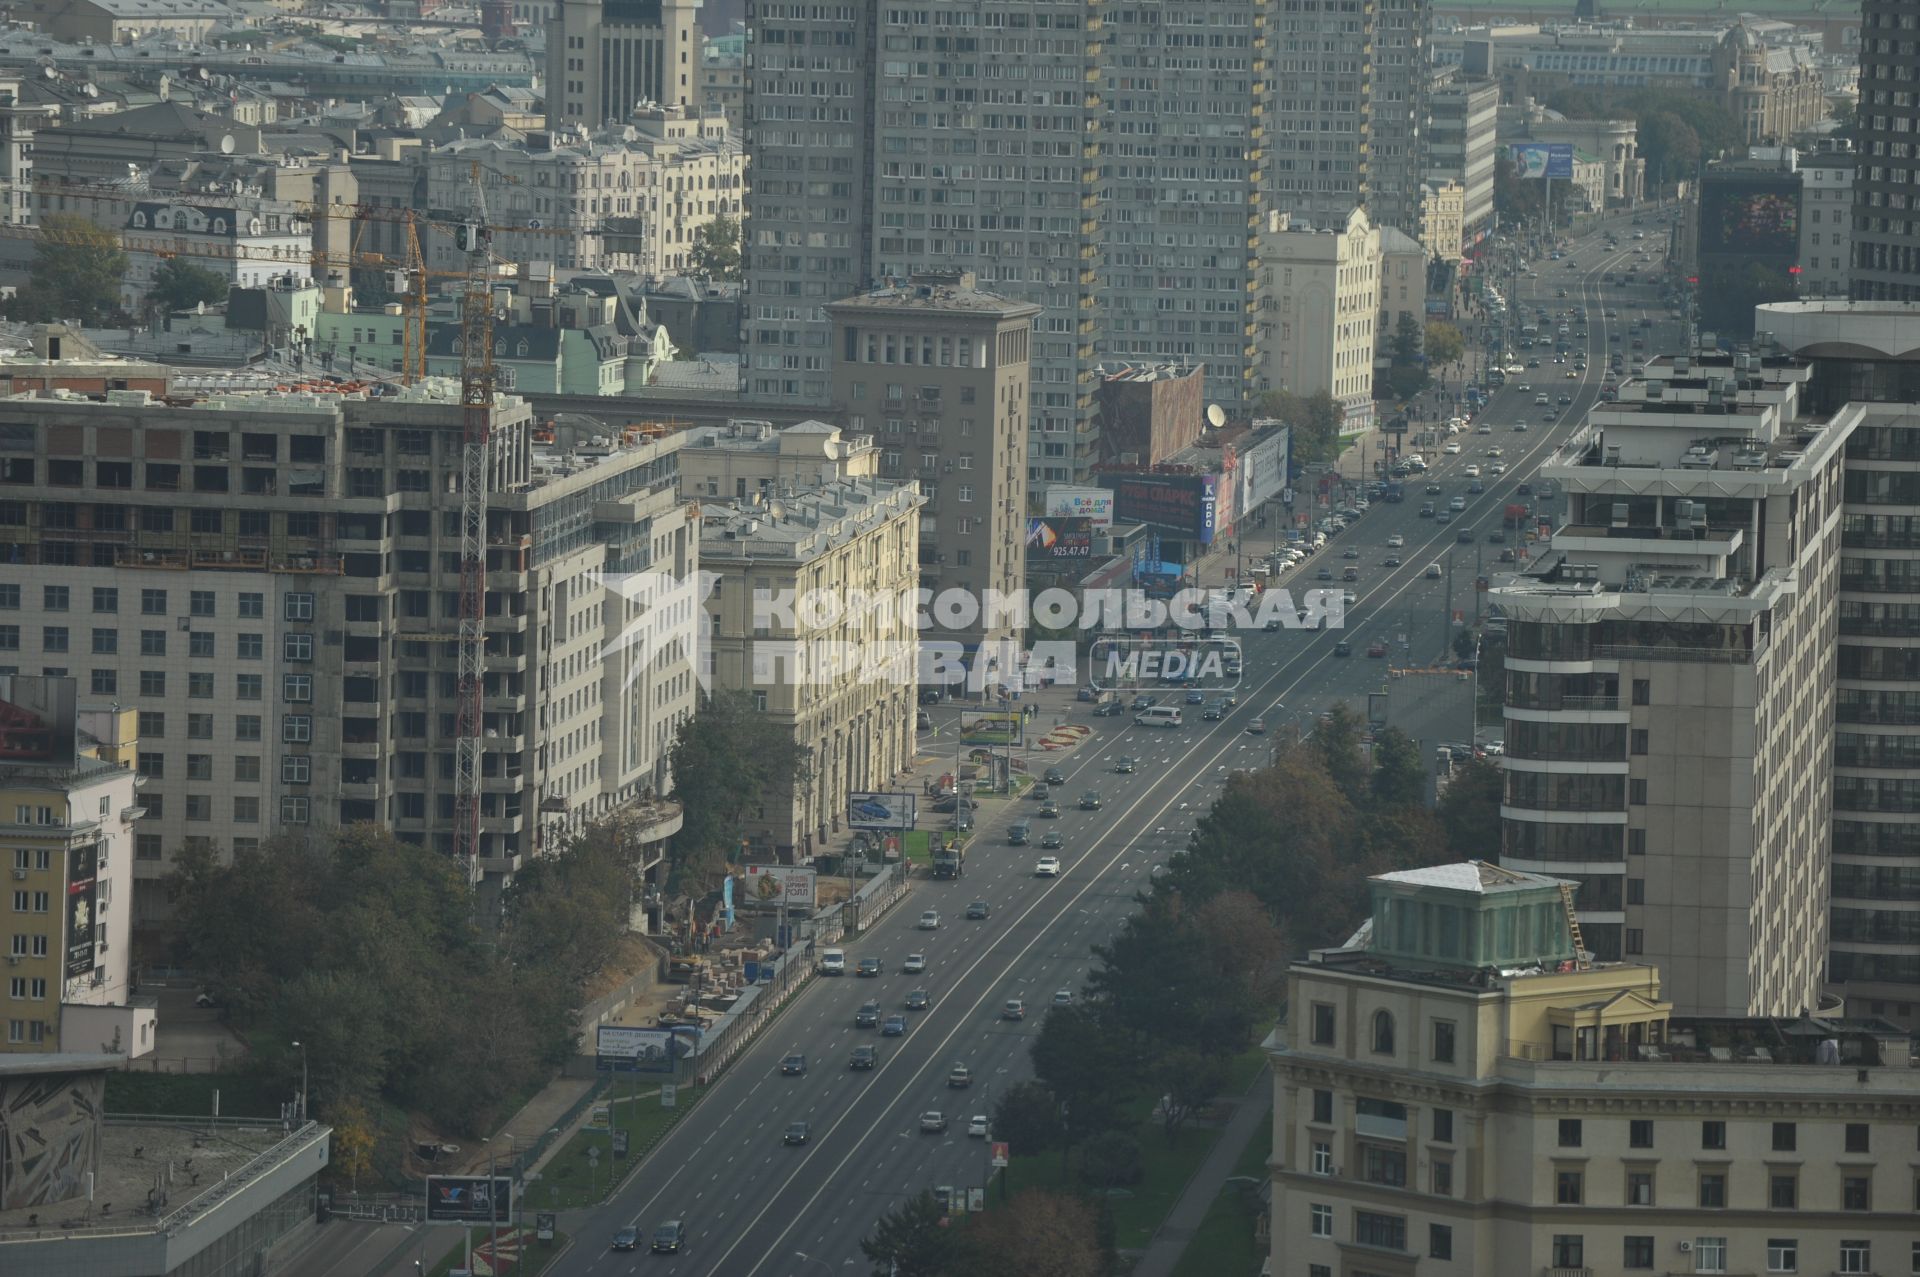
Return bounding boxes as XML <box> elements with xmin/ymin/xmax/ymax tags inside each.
<box><xmin>1267</xmin><ymin>862</ymin><xmax>1920</xmax><ymax>1277</ymax></box>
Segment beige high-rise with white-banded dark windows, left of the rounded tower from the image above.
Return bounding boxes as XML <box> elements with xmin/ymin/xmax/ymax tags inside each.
<box><xmin>1492</xmin><ymin>355</ymin><xmax>1853</xmax><ymax>1016</ymax></box>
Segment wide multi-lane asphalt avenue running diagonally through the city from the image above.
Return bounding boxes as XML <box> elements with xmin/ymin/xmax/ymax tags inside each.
<box><xmin>528</xmin><ymin>209</ymin><xmax>1680</xmax><ymax>1277</ymax></box>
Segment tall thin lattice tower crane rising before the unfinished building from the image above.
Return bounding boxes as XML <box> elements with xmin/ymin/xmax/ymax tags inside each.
<box><xmin>453</xmin><ymin>163</ymin><xmax>493</xmax><ymax>881</ymax></box>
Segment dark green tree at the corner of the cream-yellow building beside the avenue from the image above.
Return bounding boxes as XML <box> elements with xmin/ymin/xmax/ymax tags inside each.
<box><xmin>670</xmin><ymin>691</ymin><xmax>812</xmax><ymax>891</ymax></box>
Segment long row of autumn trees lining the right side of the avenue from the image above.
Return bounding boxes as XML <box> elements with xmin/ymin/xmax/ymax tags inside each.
<box><xmin>864</xmin><ymin>705</ymin><xmax>1500</xmax><ymax>1277</ymax></box>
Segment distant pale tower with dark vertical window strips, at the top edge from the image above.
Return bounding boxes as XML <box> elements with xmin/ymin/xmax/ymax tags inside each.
<box><xmin>547</xmin><ymin>0</ymin><xmax>701</xmax><ymax>129</ymax></box>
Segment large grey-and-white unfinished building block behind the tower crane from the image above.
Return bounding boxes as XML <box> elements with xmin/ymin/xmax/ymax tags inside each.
<box><xmin>0</xmin><ymin>380</ymin><xmax>699</xmax><ymax>914</ymax></box>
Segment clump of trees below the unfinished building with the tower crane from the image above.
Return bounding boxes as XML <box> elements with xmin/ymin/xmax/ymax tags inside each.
<box><xmin>169</xmin><ymin>820</ymin><xmax>636</xmax><ymax>1135</ymax></box>
